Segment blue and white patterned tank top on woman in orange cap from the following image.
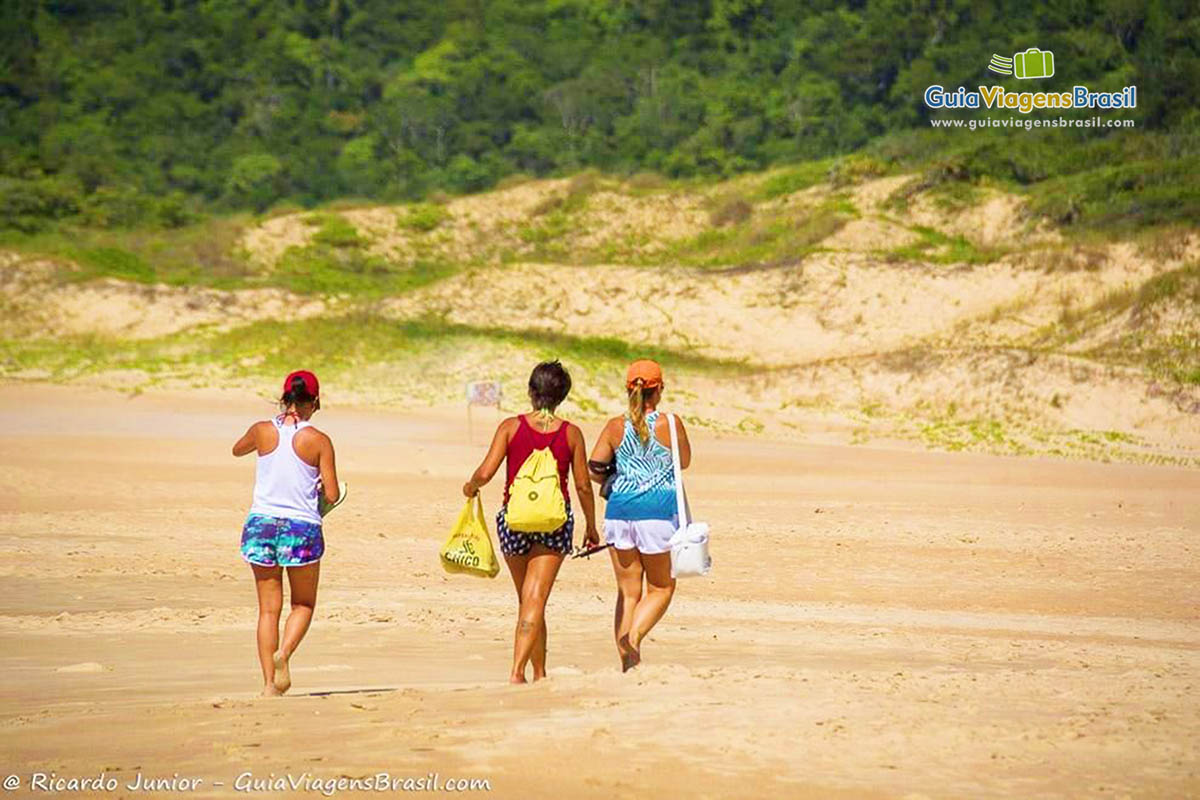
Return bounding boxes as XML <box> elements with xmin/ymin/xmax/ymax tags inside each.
<box><xmin>604</xmin><ymin>411</ymin><xmax>676</xmax><ymax>519</ymax></box>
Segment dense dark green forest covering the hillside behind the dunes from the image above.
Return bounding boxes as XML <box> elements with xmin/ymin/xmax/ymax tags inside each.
<box><xmin>0</xmin><ymin>0</ymin><xmax>1200</xmax><ymax>230</ymax></box>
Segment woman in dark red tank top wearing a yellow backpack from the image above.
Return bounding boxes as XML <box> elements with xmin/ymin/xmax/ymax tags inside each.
<box><xmin>462</xmin><ymin>361</ymin><xmax>600</xmax><ymax>684</ymax></box>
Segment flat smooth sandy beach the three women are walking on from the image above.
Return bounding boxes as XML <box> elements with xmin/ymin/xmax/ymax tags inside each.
<box><xmin>0</xmin><ymin>383</ymin><xmax>1200</xmax><ymax>798</ymax></box>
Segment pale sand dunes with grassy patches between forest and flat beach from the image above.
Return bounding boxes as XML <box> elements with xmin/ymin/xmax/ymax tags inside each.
<box><xmin>0</xmin><ymin>173</ymin><xmax>1200</xmax><ymax>465</ymax></box>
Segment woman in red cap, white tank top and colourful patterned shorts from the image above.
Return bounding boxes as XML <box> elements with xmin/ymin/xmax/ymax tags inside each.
<box><xmin>233</xmin><ymin>371</ymin><xmax>338</xmax><ymax>694</ymax></box>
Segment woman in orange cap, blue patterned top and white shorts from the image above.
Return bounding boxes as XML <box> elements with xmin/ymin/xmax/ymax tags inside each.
<box><xmin>592</xmin><ymin>360</ymin><xmax>691</xmax><ymax>672</ymax></box>
